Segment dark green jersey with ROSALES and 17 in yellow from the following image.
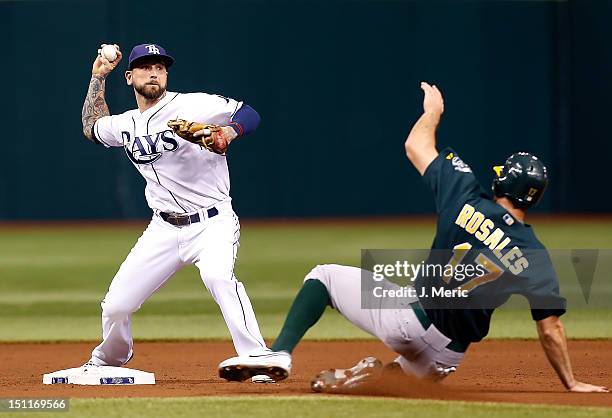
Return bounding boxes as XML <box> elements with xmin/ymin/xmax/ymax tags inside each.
<box><xmin>415</xmin><ymin>148</ymin><xmax>566</xmax><ymax>345</ymax></box>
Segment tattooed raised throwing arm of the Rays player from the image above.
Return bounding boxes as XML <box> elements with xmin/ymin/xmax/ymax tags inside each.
<box><xmin>81</xmin><ymin>45</ymin><xmax>122</xmax><ymax>141</ymax></box>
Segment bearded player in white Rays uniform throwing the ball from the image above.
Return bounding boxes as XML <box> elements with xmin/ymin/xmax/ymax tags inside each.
<box><xmin>82</xmin><ymin>44</ymin><xmax>267</xmax><ymax>378</ymax></box>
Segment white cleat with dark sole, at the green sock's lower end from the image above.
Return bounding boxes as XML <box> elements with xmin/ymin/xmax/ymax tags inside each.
<box><xmin>219</xmin><ymin>351</ymin><xmax>291</xmax><ymax>382</ymax></box>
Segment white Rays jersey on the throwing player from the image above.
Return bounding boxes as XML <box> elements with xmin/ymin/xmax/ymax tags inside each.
<box><xmin>94</xmin><ymin>91</ymin><xmax>242</xmax><ymax>213</ymax></box>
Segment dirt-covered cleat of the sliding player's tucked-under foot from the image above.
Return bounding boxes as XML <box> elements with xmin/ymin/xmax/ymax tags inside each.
<box><xmin>310</xmin><ymin>357</ymin><xmax>383</xmax><ymax>392</ymax></box>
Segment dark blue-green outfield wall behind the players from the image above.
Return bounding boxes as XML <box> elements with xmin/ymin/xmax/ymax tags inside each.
<box><xmin>0</xmin><ymin>0</ymin><xmax>612</xmax><ymax>220</ymax></box>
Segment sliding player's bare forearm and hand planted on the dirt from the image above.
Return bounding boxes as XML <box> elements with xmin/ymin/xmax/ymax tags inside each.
<box><xmin>536</xmin><ymin>316</ymin><xmax>609</xmax><ymax>392</ymax></box>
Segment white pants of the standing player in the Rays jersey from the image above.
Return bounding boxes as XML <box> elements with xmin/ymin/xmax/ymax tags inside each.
<box><xmin>92</xmin><ymin>202</ymin><xmax>266</xmax><ymax>366</ymax></box>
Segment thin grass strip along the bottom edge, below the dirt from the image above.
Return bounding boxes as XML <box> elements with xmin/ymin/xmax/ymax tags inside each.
<box><xmin>3</xmin><ymin>396</ymin><xmax>610</xmax><ymax>418</ymax></box>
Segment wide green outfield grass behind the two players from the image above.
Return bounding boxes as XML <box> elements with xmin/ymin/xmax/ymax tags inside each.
<box><xmin>0</xmin><ymin>220</ymin><xmax>612</xmax><ymax>341</ymax></box>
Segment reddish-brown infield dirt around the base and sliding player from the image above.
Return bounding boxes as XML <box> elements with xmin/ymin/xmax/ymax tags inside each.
<box><xmin>0</xmin><ymin>340</ymin><xmax>612</xmax><ymax>407</ymax></box>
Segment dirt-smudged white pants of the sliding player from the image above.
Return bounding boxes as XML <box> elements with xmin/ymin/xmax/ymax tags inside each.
<box><xmin>304</xmin><ymin>264</ymin><xmax>464</xmax><ymax>377</ymax></box>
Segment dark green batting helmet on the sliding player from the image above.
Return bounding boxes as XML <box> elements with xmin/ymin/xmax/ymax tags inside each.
<box><xmin>493</xmin><ymin>152</ymin><xmax>548</xmax><ymax>209</ymax></box>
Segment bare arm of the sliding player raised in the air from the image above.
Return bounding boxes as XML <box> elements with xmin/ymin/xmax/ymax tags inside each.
<box><xmin>405</xmin><ymin>82</ymin><xmax>444</xmax><ymax>175</ymax></box>
